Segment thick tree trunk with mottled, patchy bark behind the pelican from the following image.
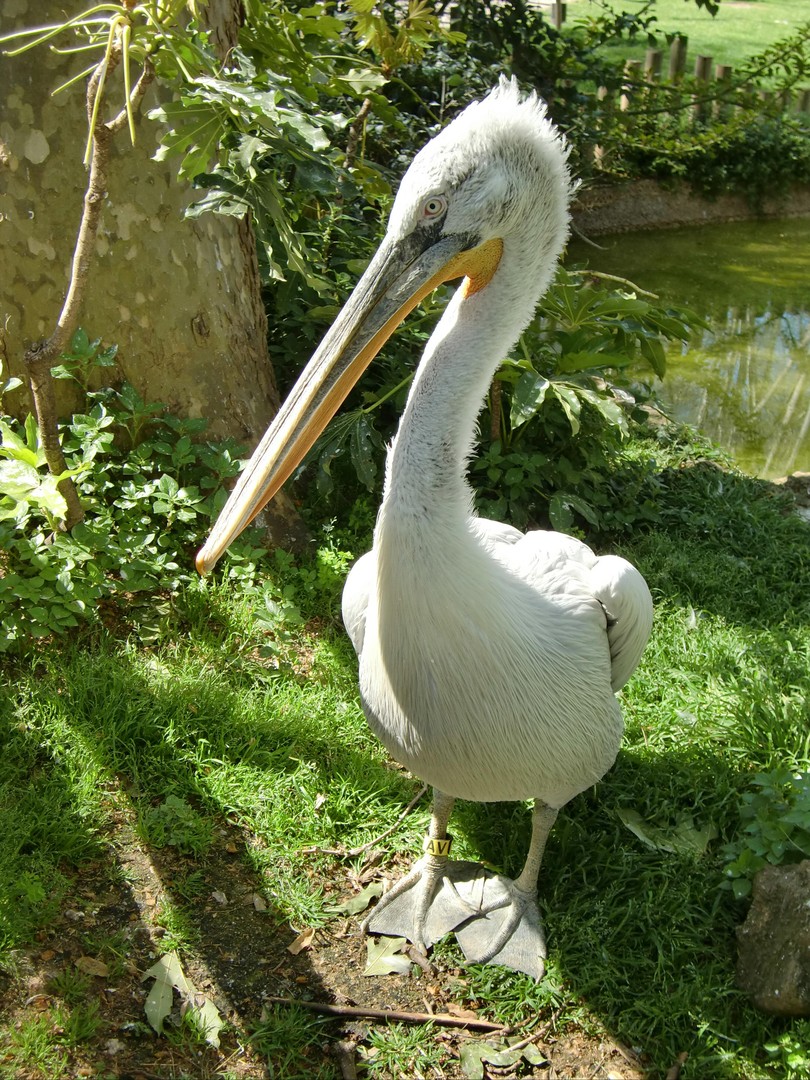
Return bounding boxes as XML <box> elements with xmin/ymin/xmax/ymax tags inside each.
<box><xmin>0</xmin><ymin>0</ymin><xmax>305</xmax><ymax>546</ymax></box>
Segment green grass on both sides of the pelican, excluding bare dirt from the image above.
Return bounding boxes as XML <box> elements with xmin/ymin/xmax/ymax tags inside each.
<box><xmin>0</xmin><ymin>429</ymin><xmax>810</xmax><ymax>1080</ymax></box>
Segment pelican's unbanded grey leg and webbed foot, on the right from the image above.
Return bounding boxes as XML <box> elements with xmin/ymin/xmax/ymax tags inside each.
<box><xmin>456</xmin><ymin>799</ymin><xmax>557</xmax><ymax>980</ymax></box>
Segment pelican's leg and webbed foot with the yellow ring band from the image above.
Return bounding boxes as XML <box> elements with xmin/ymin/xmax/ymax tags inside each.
<box><xmin>362</xmin><ymin>788</ymin><xmax>481</xmax><ymax>951</ymax></box>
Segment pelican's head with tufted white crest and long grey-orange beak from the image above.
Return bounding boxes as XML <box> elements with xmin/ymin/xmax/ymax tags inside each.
<box><xmin>197</xmin><ymin>78</ymin><xmax>572</xmax><ymax>573</ymax></box>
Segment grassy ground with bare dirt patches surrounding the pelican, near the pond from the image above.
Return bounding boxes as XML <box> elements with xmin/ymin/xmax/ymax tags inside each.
<box><xmin>0</xmin><ymin>425</ymin><xmax>810</xmax><ymax>1080</ymax></box>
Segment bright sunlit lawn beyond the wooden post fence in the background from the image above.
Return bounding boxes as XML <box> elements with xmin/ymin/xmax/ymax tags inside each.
<box><xmin>568</xmin><ymin>0</ymin><xmax>810</xmax><ymax>71</ymax></box>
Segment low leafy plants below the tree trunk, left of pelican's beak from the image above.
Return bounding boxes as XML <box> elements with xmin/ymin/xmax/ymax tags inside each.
<box><xmin>0</xmin><ymin>332</ymin><xmax>241</xmax><ymax>651</ymax></box>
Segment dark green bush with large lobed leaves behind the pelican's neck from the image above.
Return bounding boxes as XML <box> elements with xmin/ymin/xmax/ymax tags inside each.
<box><xmin>302</xmin><ymin>270</ymin><xmax>703</xmax><ymax>531</ymax></box>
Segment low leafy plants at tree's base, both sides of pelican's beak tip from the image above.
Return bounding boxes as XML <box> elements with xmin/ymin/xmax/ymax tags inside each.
<box><xmin>0</xmin><ymin>330</ymin><xmax>360</xmax><ymax>653</ymax></box>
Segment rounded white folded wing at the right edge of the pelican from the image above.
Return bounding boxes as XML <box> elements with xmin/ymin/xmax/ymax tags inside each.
<box><xmin>591</xmin><ymin>555</ymin><xmax>652</xmax><ymax>690</ymax></box>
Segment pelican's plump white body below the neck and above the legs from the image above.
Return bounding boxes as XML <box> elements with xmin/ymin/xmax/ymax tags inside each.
<box><xmin>343</xmin><ymin>509</ymin><xmax>646</xmax><ymax>808</ymax></box>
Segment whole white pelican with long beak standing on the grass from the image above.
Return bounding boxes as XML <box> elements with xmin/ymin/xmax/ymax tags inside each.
<box><xmin>198</xmin><ymin>79</ymin><xmax>652</xmax><ymax>980</ymax></box>
